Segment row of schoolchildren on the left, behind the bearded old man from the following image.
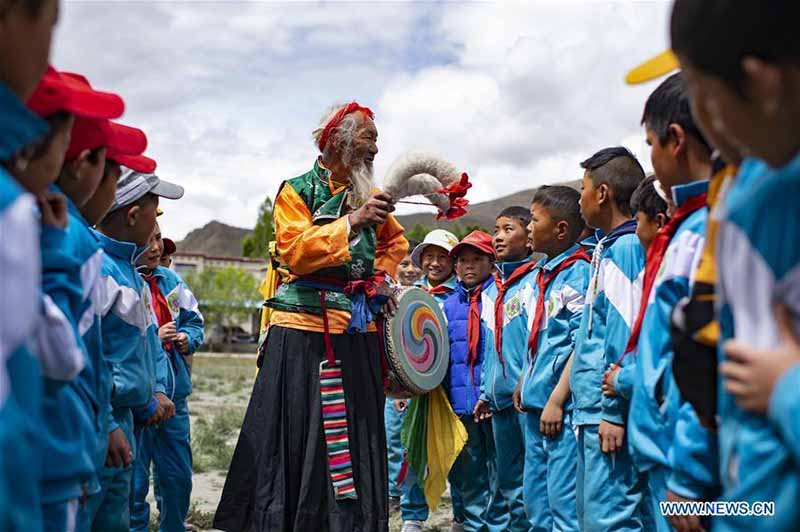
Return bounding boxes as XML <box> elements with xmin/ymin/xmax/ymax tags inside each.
<box><xmin>0</xmin><ymin>0</ymin><xmax>203</xmax><ymax>532</ymax></box>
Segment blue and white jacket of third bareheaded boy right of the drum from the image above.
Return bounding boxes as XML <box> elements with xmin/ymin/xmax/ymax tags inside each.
<box><xmin>570</xmin><ymin>221</ymin><xmax>644</xmax><ymax>425</ymax></box>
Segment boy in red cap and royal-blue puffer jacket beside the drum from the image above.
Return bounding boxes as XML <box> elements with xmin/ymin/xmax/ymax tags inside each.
<box><xmin>443</xmin><ymin>231</ymin><xmax>508</xmax><ymax>532</ymax></box>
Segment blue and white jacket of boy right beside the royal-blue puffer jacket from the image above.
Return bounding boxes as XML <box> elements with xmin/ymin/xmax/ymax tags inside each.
<box><xmin>481</xmin><ymin>258</ymin><xmax>536</xmax><ymax>412</ymax></box>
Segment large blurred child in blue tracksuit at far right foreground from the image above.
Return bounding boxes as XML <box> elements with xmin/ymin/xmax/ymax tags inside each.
<box><xmin>672</xmin><ymin>1</ymin><xmax>800</xmax><ymax>531</ymax></box>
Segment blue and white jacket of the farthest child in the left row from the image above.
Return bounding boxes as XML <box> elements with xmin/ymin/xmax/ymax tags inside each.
<box><xmin>148</xmin><ymin>266</ymin><xmax>203</xmax><ymax>401</ymax></box>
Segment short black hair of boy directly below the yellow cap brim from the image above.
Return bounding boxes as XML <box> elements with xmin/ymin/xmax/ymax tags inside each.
<box><xmin>642</xmin><ymin>72</ymin><xmax>711</xmax><ymax>152</ymax></box>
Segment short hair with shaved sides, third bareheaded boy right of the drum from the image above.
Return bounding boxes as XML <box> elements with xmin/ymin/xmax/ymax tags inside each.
<box><xmin>581</xmin><ymin>146</ymin><xmax>644</xmax><ymax>216</ymax></box>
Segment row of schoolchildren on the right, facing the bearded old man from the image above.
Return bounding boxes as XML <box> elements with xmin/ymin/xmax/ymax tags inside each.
<box><xmin>390</xmin><ymin>0</ymin><xmax>800</xmax><ymax>532</ymax></box>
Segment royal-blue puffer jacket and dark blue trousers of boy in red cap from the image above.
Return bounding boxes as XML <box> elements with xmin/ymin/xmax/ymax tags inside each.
<box><xmin>442</xmin><ymin>278</ymin><xmax>508</xmax><ymax>532</ymax></box>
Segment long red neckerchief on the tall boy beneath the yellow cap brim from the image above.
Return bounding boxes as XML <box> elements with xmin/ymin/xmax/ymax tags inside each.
<box><xmin>617</xmin><ymin>193</ymin><xmax>706</xmax><ymax>364</ymax></box>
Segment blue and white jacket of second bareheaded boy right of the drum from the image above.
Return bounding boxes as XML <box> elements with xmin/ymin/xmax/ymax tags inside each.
<box><xmin>520</xmin><ymin>244</ymin><xmax>591</xmax><ymax>410</ymax></box>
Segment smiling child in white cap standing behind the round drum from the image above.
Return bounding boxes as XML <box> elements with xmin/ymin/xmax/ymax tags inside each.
<box><xmin>400</xmin><ymin>229</ymin><xmax>463</xmax><ymax>532</ymax></box>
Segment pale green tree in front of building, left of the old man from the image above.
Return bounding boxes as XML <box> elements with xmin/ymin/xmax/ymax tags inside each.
<box><xmin>184</xmin><ymin>266</ymin><xmax>261</xmax><ymax>345</ymax></box>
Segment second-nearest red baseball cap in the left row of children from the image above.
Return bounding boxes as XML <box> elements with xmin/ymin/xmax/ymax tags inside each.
<box><xmin>66</xmin><ymin>118</ymin><xmax>147</xmax><ymax>161</ymax></box>
